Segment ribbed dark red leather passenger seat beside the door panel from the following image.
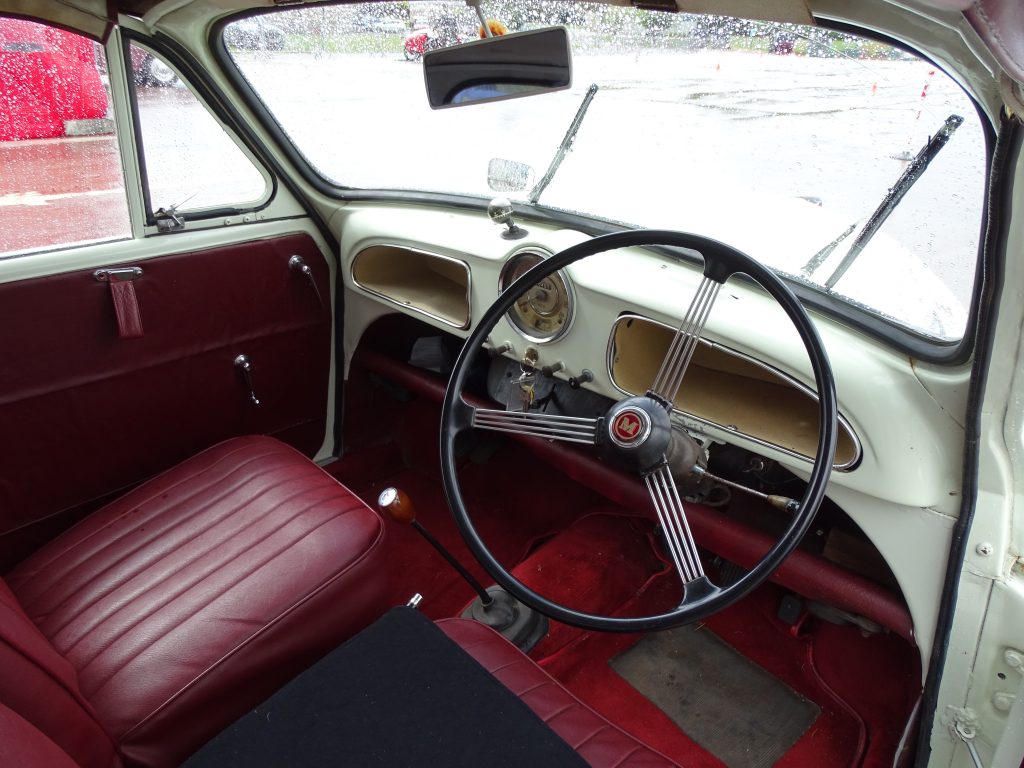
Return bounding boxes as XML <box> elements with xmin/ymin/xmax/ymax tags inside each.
<box><xmin>0</xmin><ymin>437</ymin><xmax>386</xmax><ymax>767</ymax></box>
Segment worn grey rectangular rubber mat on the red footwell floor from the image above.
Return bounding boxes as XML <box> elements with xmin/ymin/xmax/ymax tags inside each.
<box><xmin>610</xmin><ymin>627</ymin><xmax>820</xmax><ymax>768</ymax></box>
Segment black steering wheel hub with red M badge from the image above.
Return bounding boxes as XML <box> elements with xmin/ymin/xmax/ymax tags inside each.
<box><xmin>601</xmin><ymin>397</ymin><xmax>672</xmax><ymax>472</ymax></box>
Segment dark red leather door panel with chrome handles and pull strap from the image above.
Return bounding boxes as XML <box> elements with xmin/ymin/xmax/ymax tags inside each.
<box><xmin>0</xmin><ymin>234</ymin><xmax>331</xmax><ymax>567</ymax></box>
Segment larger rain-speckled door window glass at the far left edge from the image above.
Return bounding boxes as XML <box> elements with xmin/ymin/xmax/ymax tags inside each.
<box><xmin>0</xmin><ymin>16</ymin><xmax>131</xmax><ymax>258</ymax></box>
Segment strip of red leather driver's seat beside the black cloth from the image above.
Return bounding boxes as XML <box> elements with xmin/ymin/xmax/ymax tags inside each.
<box><xmin>436</xmin><ymin>618</ymin><xmax>678</xmax><ymax>768</ymax></box>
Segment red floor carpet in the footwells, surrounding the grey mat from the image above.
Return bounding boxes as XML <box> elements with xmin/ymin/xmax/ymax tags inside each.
<box><xmin>328</xmin><ymin>382</ymin><xmax>920</xmax><ymax>768</ymax></box>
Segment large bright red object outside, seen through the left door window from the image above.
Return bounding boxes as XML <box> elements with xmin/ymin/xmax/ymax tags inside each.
<box><xmin>0</xmin><ymin>18</ymin><xmax>108</xmax><ymax>141</ymax></box>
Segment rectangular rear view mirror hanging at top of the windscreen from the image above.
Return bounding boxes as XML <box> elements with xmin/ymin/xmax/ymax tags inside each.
<box><xmin>423</xmin><ymin>27</ymin><xmax>572</xmax><ymax>110</ymax></box>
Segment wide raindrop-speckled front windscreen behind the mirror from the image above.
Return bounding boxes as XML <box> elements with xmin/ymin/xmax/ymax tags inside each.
<box><xmin>224</xmin><ymin>0</ymin><xmax>986</xmax><ymax>342</ymax></box>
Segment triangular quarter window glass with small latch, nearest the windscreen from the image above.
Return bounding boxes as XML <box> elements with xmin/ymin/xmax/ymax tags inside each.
<box><xmin>128</xmin><ymin>43</ymin><xmax>269</xmax><ymax>218</ymax></box>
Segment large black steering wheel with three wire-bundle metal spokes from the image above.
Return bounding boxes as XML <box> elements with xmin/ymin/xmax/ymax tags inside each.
<box><xmin>440</xmin><ymin>229</ymin><xmax>839</xmax><ymax>632</ymax></box>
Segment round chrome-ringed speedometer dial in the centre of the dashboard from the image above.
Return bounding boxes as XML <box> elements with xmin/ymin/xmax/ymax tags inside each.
<box><xmin>498</xmin><ymin>251</ymin><xmax>573</xmax><ymax>343</ymax></box>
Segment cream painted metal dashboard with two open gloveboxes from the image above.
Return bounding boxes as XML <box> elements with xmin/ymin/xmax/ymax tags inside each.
<box><xmin>331</xmin><ymin>203</ymin><xmax>967</xmax><ymax>652</ymax></box>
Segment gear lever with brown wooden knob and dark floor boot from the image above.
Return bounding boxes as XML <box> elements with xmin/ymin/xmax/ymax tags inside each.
<box><xmin>377</xmin><ymin>487</ymin><xmax>548</xmax><ymax>653</ymax></box>
